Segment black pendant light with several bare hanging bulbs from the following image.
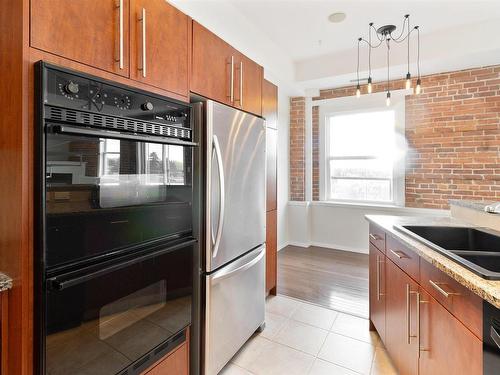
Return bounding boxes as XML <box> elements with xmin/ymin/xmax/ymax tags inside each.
<box><xmin>356</xmin><ymin>14</ymin><xmax>422</xmax><ymax>100</ymax></box>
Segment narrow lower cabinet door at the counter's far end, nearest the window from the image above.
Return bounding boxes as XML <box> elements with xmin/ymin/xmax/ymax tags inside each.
<box><xmin>369</xmin><ymin>243</ymin><xmax>386</xmax><ymax>342</ymax></box>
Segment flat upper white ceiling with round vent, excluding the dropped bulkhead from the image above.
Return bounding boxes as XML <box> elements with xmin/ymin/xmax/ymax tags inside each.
<box><xmin>231</xmin><ymin>0</ymin><xmax>500</xmax><ymax>61</ymax></box>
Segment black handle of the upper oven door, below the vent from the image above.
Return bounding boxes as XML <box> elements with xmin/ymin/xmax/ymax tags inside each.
<box><xmin>47</xmin><ymin>124</ymin><xmax>198</xmax><ymax>147</ymax></box>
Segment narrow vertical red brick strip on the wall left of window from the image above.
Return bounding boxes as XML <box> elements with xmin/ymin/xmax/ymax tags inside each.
<box><xmin>290</xmin><ymin>97</ymin><xmax>306</xmax><ymax>201</ymax></box>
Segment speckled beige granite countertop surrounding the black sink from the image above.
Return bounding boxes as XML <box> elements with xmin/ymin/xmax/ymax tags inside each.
<box><xmin>365</xmin><ymin>215</ymin><xmax>500</xmax><ymax>308</ymax></box>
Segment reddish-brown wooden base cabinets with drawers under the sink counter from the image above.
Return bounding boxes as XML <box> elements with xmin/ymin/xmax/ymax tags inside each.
<box><xmin>369</xmin><ymin>229</ymin><xmax>483</xmax><ymax>375</ymax></box>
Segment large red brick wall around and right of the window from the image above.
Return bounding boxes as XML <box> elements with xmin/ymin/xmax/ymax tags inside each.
<box><xmin>292</xmin><ymin>65</ymin><xmax>500</xmax><ymax>208</ymax></box>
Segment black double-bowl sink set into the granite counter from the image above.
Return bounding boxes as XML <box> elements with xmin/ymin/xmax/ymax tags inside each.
<box><xmin>395</xmin><ymin>225</ymin><xmax>500</xmax><ymax>280</ymax></box>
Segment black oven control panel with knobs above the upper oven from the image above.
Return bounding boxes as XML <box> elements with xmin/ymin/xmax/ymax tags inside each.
<box><xmin>43</xmin><ymin>68</ymin><xmax>190</xmax><ymax>127</ymax></box>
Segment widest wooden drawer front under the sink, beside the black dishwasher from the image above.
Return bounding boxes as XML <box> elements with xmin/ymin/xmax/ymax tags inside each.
<box><xmin>420</xmin><ymin>259</ymin><xmax>483</xmax><ymax>338</ymax></box>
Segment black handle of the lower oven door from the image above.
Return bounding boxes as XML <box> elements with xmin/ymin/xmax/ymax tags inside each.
<box><xmin>47</xmin><ymin>238</ymin><xmax>197</xmax><ymax>291</ymax></box>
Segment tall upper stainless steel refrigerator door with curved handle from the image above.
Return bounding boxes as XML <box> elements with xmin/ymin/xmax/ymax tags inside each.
<box><xmin>206</xmin><ymin>101</ymin><xmax>266</xmax><ymax>272</ymax></box>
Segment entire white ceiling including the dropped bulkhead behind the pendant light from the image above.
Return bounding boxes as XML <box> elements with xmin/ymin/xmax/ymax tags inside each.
<box><xmin>168</xmin><ymin>0</ymin><xmax>500</xmax><ymax>95</ymax></box>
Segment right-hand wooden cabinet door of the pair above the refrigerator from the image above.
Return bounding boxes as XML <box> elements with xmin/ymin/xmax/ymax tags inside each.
<box><xmin>234</xmin><ymin>52</ymin><xmax>264</xmax><ymax>116</ymax></box>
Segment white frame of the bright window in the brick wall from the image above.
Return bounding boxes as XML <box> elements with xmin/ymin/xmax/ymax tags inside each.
<box><xmin>313</xmin><ymin>90</ymin><xmax>411</xmax><ymax>207</ymax></box>
